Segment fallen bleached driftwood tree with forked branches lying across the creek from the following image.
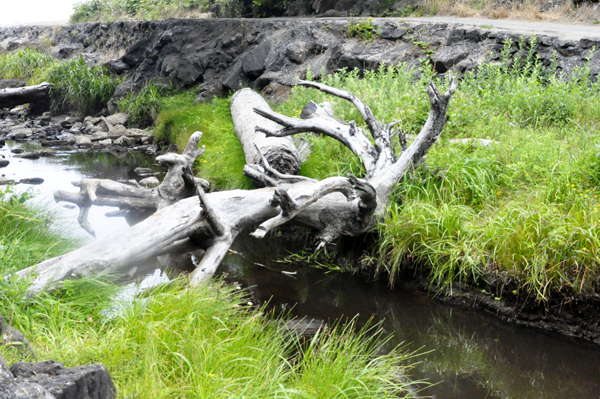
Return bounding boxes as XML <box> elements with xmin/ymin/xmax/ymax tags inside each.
<box><xmin>19</xmin><ymin>78</ymin><xmax>456</xmax><ymax>293</ymax></box>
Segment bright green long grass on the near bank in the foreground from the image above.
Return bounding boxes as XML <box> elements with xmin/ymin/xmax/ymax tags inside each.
<box><xmin>0</xmin><ymin>194</ymin><xmax>418</xmax><ymax>398</ymax></box>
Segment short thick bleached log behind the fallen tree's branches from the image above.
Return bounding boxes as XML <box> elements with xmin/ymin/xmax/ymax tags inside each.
<box><xmin>231</xmin><ymin>89</ymin><xmax>302</xmax><ymax>175</ymax></box>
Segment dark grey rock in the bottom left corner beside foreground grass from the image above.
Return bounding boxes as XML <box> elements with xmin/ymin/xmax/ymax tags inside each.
<box><xmin>0</xmin><ymin>358</ymin><xmax>117</xmax><ymax>399</ymax></box>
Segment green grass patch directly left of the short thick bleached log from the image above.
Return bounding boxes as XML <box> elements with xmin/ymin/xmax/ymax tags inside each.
<box><xmin>155</xmin><ymin>91</ymin><xmax>253</xmax><ymax>190</ymax></box>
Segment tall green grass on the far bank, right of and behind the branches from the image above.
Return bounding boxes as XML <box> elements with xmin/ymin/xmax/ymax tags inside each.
<box><xmin>152</xmin><ymin>38</ymin><xmax>600</xmax><ymax>299</ymax></box>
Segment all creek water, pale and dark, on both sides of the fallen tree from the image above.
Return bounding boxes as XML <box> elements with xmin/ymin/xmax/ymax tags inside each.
<box><xmin>0</xmin><ymin>143</ymin><xmax>600</xmax><ymax>399</ymax></box>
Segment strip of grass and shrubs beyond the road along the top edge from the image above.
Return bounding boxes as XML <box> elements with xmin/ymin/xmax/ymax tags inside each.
<box><xmin>71</xmin><ymin>0</ymin><xmax>600</xmax><ymax>23</ymax></box>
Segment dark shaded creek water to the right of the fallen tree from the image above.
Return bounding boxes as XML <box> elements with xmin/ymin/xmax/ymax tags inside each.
<box><xmin>221</xmin><ymin>234</ymin><xmax>600</xmax><ymax>399</ymax></box>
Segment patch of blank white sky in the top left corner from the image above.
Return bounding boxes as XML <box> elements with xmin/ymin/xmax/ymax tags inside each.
<box><xmin>0</xmin><ymin>0</ymin><xmax>80</xmax><ymax>26</ymax></box>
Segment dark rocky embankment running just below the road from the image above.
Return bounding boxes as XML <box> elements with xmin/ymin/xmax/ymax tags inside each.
<box><xmin>0</xmin><ymin>19</ymin><xmax>600</xmax><ymax>108</ymax></box>
